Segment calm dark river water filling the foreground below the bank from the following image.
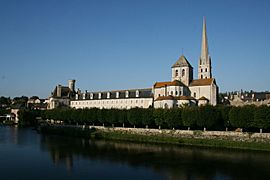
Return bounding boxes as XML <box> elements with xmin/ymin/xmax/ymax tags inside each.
<box><xmin>0</xmin><ymin>126</ymin><xmax>270</xmax><ymax>180</ymax></box>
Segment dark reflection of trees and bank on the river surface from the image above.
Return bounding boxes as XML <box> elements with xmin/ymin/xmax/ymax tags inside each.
<box><xmin>41</xmin><ymin>135</ymin><xmax>270</xmax><ymax>179</ymax></box>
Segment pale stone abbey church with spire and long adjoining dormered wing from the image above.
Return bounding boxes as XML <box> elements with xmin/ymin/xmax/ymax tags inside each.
<box><xmin>49</xmin><ymin>19</ymin><xmax>218</xmax><ymax>109</ymax></box>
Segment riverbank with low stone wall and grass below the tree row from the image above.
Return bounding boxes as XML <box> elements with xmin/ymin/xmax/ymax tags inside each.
<box><xmin>40</xmin><ymin>126</ymin><xmax>270</xmax><ymax>151</ymax></box>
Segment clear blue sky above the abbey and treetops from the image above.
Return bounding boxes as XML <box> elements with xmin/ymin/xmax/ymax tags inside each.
<box><xmin>0</xmin><ymin>0</ymin><xmax>270</xmax><ymax>98</ymax></box>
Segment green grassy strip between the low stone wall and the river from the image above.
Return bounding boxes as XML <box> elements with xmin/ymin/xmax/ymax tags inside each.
<box><xmin>40</xmin><ymin>126</ymin><xmax>270</xmax><ymax>151</ymax></box>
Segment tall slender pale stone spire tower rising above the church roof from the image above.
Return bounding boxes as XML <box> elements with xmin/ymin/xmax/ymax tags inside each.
<box><xmin>198</xmin><ymin>17</ymin><xmax>212</xmax><ymax>79</ymax></box>
